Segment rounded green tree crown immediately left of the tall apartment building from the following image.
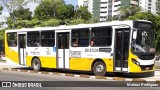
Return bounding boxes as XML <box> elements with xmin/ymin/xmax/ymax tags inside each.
<box><xmin>74</xmin><ymin>6</ymin><xmax>92</xmax><ymax>20</ymax></box>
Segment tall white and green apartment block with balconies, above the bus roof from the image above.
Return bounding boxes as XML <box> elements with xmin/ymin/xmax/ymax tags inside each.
<box><xmin>78</xmin><ymin>0</ymin><xmax>138</xmax><ymax>22</ymax></box>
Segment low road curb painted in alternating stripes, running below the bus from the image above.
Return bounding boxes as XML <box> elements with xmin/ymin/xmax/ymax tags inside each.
<box><xmin>0</xmin><ymin>68</ymin><xmax>160</xmax><ymax>81</ymax></box>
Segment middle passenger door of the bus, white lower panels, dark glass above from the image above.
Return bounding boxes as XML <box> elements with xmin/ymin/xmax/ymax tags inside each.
<box><xmin>56</xmin><ymin>32</ymin><xmax>70</xmax><ymax>69</ymax></box>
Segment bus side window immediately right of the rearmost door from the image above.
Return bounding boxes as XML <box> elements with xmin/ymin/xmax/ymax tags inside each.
<box><xmin>27</xmin><ymin>31</ymin><xmax>40</xmax><ymax>47</ymax></box>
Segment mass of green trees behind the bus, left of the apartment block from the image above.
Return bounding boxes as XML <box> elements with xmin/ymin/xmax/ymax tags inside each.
<box><xmin>3</xmin><ymin>0</ymin><xmax>92</xmax><ymax>28</ymax></box>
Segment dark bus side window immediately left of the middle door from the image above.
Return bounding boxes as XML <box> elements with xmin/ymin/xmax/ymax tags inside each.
<box><xmin>41</xmin><ymin>31</ymin><xmax>55</xmax><ymax>47</ymax></box>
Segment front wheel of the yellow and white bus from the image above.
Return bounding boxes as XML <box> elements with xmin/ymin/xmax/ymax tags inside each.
<box><xmin>93</xmin><ymin>61</ymin><xmax>106</xmax><ymax>76</ymax></box>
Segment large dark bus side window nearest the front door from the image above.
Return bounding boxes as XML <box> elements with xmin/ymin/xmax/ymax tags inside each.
<box><xmin>90</xmin><ymin>27</ymin><xmax>112</xmax><ymax>46</ymax></box>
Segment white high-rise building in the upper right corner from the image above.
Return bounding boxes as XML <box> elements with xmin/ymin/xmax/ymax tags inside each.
<box><xmin>139</xmin><ymin>0</ymin><xmax>157</xmax><ymax>14</ymax></box>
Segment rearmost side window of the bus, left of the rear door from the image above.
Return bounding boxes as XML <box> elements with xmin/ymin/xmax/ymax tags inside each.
<box><xmin>7</xmin><ymin>33</ymin><xmax>17</xmax><ymax>47</ymax></box>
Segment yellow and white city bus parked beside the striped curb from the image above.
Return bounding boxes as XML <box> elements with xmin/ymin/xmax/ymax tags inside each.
<box><xmin>5</xmin><ymin>20</ymin><xmax>155</xmax><ymax>76</ymax></box>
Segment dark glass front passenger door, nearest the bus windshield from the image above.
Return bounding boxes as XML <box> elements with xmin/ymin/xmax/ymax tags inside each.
<box><xmin>114</xmin><ymin>28</ymin><xmax>130</xmax><ymax>72</ymax></box>
